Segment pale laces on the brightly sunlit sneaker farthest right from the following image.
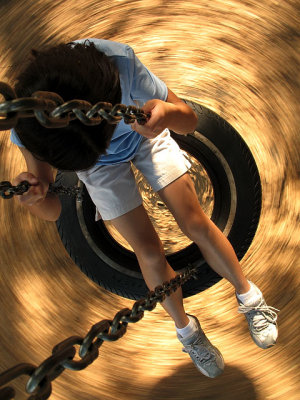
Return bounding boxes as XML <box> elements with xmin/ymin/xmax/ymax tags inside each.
<box><xmin>238</xmin><ymin>300</ymin><xmax>280</xmax><ymax>331</ymax></box>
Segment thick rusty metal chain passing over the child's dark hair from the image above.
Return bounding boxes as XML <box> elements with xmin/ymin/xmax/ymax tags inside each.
<box><xmin>0</xmin><ymin>82</ymin><xmax>150</xmax><ymax>131</ymax></box>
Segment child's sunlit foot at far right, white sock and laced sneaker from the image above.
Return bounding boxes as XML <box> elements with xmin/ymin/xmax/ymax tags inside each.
<box><xmin>236</xmin><ymin>281</ymin><xmax>279</xmax><ymax>349</ymax></box>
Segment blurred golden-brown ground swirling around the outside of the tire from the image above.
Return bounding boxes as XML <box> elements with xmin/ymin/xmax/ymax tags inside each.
<box><xmin>0</xmin><ymin>0</ymin><xmax>300</xmax><ymax>400</ymax></box>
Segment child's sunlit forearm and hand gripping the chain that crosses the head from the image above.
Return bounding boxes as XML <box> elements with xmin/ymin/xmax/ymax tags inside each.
<box><xmin>131</xmin><ymin>89</ymin><xmax>197</xmax><ymax>138</ymax></box>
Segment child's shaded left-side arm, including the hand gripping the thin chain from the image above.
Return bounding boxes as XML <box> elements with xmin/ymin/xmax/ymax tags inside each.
<box><xmin>12</xmin><ymin>147</ymin><xmax>61</xmax><ymax>221</ymax></box>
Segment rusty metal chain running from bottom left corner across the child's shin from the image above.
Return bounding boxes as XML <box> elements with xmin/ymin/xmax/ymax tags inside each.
<box><xmin>0</xmin><ymin>265</ymin><xmax>197</xmax><ymax>400</ymax></box>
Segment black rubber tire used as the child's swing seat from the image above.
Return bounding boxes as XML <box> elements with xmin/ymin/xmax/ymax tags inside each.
<box><xmin>56</xmin><ymin>101</ymin><xmax>261</xmax><ymax>300</ymax></box>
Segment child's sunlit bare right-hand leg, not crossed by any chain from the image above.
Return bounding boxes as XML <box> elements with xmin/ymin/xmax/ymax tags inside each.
<box><xmin>159</xmin><ymin>173</ymin><xmax>250</xmax><ymax>294</ymax></box>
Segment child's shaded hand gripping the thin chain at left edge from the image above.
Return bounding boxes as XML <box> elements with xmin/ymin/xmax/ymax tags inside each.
<box><xmin>12</xmin><ymin>172</ymin><xmax>49</xmax><ymax>206</ymax></box>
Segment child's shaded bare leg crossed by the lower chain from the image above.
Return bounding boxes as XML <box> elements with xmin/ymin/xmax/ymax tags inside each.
<box><xmin>111</xmin><ymin>206</ymin><xmax>189</xmax><ymax>328</ymax></box>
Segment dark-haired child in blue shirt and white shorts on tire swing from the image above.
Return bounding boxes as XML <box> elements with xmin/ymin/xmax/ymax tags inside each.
<box><xmin>11</xmin><ymin>39</ymin><xmax>278</xmax><ymax>378</ymax></box>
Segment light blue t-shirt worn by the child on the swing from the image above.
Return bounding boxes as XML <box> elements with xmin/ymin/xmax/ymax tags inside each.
<box><xmin>10</xmin><ymin>39</ymin><xmax>168</xmax><ymax>165</ymax></box>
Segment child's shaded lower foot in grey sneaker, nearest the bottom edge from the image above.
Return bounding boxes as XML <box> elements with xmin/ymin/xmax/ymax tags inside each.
<box><xmin>177</xmin><ymin>314</ymin><xmax>224</xmax><ymax>378</ymax></box>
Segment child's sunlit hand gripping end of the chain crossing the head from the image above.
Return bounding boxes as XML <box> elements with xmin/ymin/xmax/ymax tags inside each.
<box><xmin>131</xmin><ymin>99</ymin><xmax>173</xmax><ymax>139</ymax></box>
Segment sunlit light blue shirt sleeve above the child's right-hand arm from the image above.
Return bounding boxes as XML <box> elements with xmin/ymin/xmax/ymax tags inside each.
<box><xmin>128</xmin><ymin>46</ymin><xmax>168</xmax><ymax>107</ymax></box>
